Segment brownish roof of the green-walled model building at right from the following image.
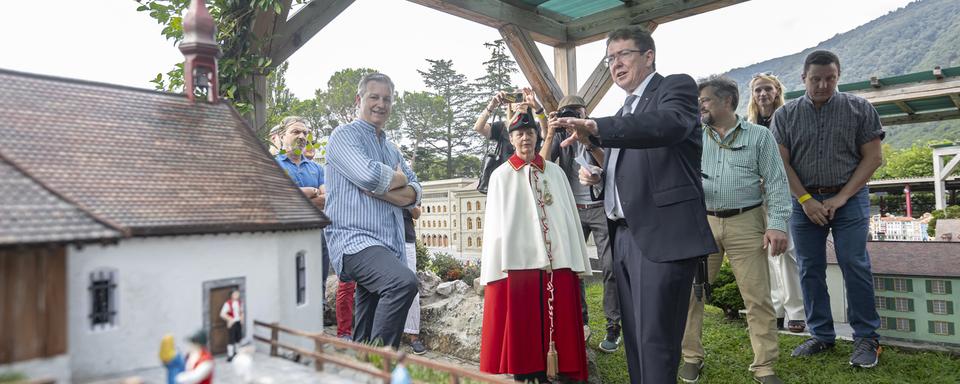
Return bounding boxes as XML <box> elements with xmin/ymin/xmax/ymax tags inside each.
<box><xmin>827</xmin><ymin>241</ymin><xmax>960</xmax><ymax>277</ymax></box>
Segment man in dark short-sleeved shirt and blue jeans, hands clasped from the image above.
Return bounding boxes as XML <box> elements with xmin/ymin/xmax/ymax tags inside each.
<box><xmin>770</xmin><ymin>51</ymin><xmax>884</xmax><ymax>368</ymax></box>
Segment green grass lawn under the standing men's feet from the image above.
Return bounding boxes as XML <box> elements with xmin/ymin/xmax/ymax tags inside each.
<box><xmin>587</xmin><ymin>284</ymin><xmax>960</xmax><ymax>384</ymax></box>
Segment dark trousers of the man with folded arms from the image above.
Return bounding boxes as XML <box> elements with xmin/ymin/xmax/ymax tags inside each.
<box><xmin>343</xmin><ymin>246</ymin><xmax>417</xmax><ymax>349</ymax></box>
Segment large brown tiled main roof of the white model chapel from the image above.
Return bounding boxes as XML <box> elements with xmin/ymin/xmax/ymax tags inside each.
<box><xmin>0</xmin><ymin>70</ymin><xmax>329</xmax><ymax>236</ymax></box>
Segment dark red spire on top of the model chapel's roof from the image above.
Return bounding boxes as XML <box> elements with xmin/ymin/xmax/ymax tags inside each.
<box><xmin>180</xmin><ymin>0</ymin><xmax>220</xmax><ymax>103</ymax></box>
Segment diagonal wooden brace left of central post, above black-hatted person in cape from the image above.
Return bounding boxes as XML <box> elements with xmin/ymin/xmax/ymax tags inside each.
<box><xmin>500</xmin><ymin>24</ymin><xmax>563</xmax><ymax>111</ymax></box>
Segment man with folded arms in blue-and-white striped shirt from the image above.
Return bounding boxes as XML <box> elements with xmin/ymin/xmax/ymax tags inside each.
<box><xmin>326</xmin><ymin>73</ymin><xmax>421</xmax><ymax>349</ymax></box>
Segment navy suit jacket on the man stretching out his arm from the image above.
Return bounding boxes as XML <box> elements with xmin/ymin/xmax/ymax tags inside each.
<box><xmin>592</xmin><ymin>74</ymin><xmax>717</xmax><ymax>262</ymax></box>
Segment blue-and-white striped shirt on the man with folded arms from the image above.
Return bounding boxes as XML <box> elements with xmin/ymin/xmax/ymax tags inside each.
<box><xmin>324</xmin><ymin>119</ymin><xmax>422</xmax><ymax>275</ymax></box>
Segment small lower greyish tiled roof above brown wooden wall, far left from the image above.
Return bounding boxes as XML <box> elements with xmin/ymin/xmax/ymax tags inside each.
<box><xmin>0</xmin><ymin>157</ymin><xmax>121</xmax><ymax>246</ymax></box>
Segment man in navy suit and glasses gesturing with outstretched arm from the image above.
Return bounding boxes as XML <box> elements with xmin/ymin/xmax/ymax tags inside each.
<box><xmin>562</xmin><ymin>29</ymin><xmax>717</xmax><ymax>384</ymax></box>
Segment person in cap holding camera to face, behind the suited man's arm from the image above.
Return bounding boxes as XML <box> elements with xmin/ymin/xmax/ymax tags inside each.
<box><xmin>540</xmin><ymin>95</ymin><xmax>620</xmax><ymax>352</ymax></box>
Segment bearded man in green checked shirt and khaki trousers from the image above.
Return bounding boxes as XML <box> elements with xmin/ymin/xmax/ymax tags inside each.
<box><xmin>679</xmin><ymin>77</ymin><xmax>790</xmax><ymax>383</ymax></box>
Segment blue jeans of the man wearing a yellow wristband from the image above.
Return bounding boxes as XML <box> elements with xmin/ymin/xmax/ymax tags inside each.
<box><xmin>790</xmin><ymin>187</ymin><xmax>880</xmax><ymax>343</ymax></box>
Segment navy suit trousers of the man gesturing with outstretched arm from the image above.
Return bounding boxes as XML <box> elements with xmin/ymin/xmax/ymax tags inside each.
<box><xmin>613</xmin><ymin>225</ymin><xmax>697</xmax><ymax>384</ymax></box>
